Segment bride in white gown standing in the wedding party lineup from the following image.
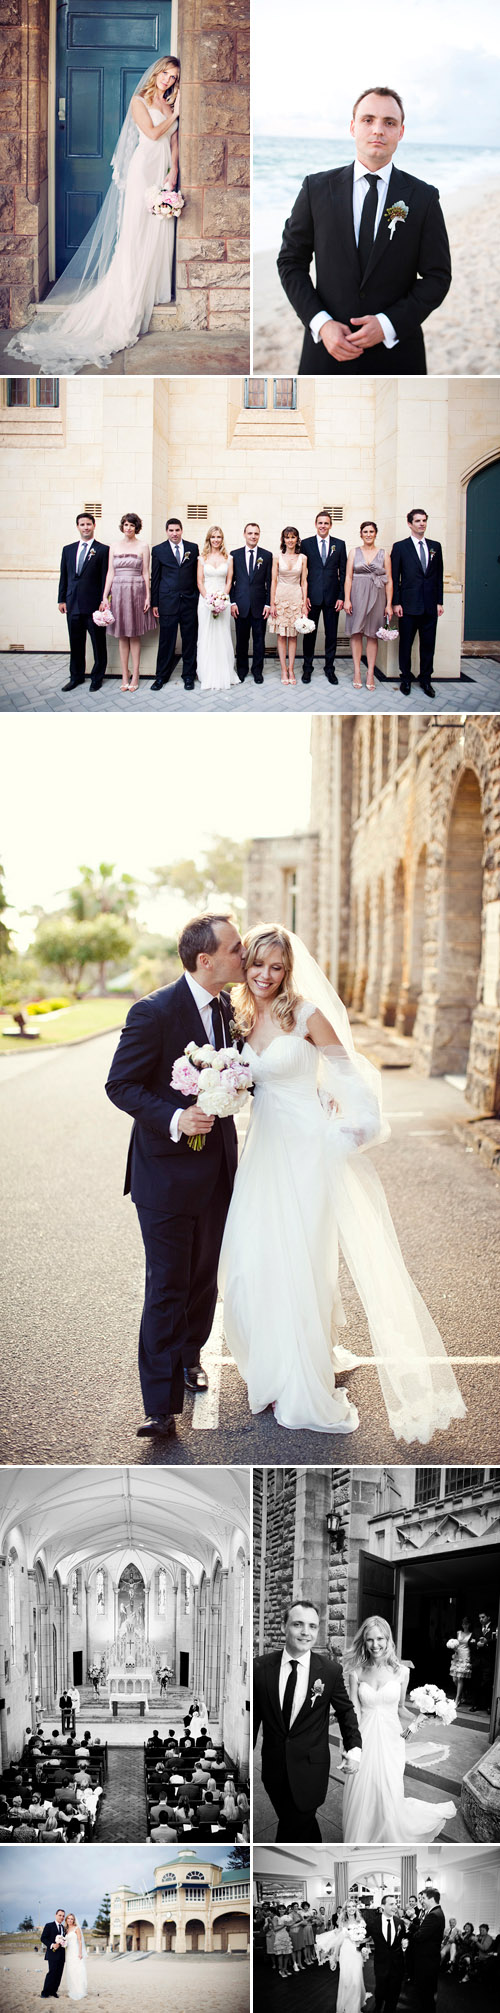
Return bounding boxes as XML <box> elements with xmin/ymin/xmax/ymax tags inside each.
<box><xmin>196</xmin><ymin>523</ymin><xmax>238</xmax><ymax>692</ymax></box>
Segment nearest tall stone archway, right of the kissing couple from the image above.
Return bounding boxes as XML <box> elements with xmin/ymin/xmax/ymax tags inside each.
<box><xmin>433</xmin><ymin>769</ymin><xmax>484</xmax><ymax>1075</ymax></box>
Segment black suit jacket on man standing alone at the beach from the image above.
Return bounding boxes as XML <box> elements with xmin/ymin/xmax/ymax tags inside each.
<box><xmin>278</xmin><ymin>163</ymin><xmax>452</xmax><ymax>376</ymax></box>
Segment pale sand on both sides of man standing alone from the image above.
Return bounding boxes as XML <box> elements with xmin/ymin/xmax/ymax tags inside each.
<box><xmin>252</xmin><ymin>179</ymin><xmax>500</xmax><ymax>376</ymax></box>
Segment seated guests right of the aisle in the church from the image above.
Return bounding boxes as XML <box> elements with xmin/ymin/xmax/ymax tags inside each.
<box><xmin>145</xmin><ymin>1703</ymin><xmax>250</xmax><ymax>1844</ymax></box>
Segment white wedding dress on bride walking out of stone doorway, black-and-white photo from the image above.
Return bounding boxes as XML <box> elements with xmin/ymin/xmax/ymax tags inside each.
<box><xmin>343</xmin><ymin>1675</ymin><xmax>456</xmax><ymax>1846</ymax></box>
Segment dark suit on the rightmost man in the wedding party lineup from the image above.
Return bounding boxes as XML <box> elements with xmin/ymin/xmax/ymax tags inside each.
<box><xmin>391</xmin><ymin>533</ymin><xmax>444</xmax><ymax>684</ymax></box>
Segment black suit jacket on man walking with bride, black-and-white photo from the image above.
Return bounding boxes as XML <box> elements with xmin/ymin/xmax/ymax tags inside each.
<box><xmin>254</xmin><ymin>1649</ymin><xmax>361</xmax><ymax>1810</ymax></box>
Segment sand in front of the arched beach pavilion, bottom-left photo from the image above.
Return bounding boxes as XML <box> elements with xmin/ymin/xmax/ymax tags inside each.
<box><xmin>0</xmin><ymin>1951</ymin><xmax>250</xmax><ymax>2013</ymax></box>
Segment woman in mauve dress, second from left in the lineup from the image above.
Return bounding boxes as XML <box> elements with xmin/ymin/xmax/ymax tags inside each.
<box><xmin>100</xmin><ymin>509</ymin><xmax>155</xmax><ymax>692</ymax></box>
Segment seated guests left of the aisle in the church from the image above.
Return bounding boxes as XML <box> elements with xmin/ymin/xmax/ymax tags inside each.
<box><xmin>0</xmin><ymin>1727</ymin><xmax>107</xmax><ymax>1846</ymax></box>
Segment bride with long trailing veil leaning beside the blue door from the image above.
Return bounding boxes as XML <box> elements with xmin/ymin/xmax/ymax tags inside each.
<box><xmin>8</xmin><ymin>56</ymin><xmax>181</xmax><ymax>376</ymax></box>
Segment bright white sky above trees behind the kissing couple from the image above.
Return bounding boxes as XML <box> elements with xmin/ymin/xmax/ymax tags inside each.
<box><xmin>0</xmin><ymin>713</ymin><xmax>310</xmax><ymax>950</ymax></box>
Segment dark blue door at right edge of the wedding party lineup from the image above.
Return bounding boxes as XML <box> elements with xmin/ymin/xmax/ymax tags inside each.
<box><xmin>466</xmin><ymin>461</ymin><xmax>500</xmax><ymax>642</ymax></box>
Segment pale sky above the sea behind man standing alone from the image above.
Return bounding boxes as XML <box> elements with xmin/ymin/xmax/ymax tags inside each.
<box><xmin>252</xmin><ymin>0</ymin><xmax>500</xmax><ymax>141</ymax></box>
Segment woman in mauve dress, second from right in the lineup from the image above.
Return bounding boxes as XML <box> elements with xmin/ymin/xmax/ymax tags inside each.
<box><xmin>345</xmin><ymin>517</ymin><xmax>393</xmax><ymax>692</ymax></box>
